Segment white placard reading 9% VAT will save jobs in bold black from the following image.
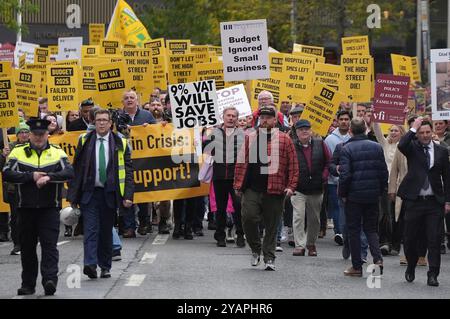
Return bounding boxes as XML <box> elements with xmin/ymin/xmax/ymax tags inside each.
<box><xmin>169</xmin><ymin>80</ymin><xmax>219</xmax><ymax>129</ymax></box>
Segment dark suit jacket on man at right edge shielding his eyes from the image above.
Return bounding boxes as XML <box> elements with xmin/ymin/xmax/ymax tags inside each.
<box><xmin>397</xmin><ymin>131</ymin><xmax>450</xmax><ymax>203</ymax></box>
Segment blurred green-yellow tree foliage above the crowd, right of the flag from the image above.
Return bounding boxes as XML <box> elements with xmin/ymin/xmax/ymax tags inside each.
<box><xmin>142</xmin><ymin>0</ymin><xmax>416</xmax><ymax>52</ymax></box>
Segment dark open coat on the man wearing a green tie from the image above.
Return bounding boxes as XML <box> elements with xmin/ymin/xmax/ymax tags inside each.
<box><xmin>67</xmin><ymin>131</ymin><xmax>134</xmax><ymax>208</ymax></box>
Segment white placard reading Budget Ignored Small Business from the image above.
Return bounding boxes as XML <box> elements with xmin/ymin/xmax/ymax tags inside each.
<box><xmin>220</xmin><ymin>20</ymin><xmax>270</xmax><ymax>82</ymax></box>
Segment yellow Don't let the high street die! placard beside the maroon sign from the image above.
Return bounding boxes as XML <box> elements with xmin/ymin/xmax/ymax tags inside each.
<box><xmin>341</xmin><ymin>55</ymin><xmax>373</xmax><ymax>102</ymax></box>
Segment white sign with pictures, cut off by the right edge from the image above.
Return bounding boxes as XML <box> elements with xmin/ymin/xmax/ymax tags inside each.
<box><xmin>430</xmin><ymin>49</ymin><xmax>450</xmax><ymax>120</ymax></box>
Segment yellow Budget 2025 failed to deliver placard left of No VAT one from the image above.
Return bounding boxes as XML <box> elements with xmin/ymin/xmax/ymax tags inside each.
<box><xmin>47</xmin><ymin>65</ymin><xmax>80</xmax><ymax>112</ymax></box>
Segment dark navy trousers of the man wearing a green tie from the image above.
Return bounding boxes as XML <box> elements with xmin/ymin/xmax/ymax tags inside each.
<box><xmin>81</xmin><ymin>188</ymin><xmax>116</xmax><ymax>270</ymax></box>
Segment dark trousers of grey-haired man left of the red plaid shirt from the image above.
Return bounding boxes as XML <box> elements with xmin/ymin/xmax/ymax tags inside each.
<box><xmin>213</xmin><ymin>180</ymin><xmax>244</xmax><ymax>240</ymax></box>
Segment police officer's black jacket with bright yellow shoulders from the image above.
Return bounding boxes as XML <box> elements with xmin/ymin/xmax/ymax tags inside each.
<box><xmin>3</xmin><ymin>143</ymin><xmax>74</xmax><ymax>208</ymax></box>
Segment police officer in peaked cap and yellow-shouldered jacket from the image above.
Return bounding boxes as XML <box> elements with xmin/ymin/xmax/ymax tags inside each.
<box><xmin>3</xmin><ymin>119</ymin><xmax>74</xmax><ymax>295</ymax></box>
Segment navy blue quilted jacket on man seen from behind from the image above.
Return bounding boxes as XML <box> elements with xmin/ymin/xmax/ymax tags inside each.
<box><xmin>339</xmin><ymin>134</ymin><xmax>389</xmax><ymax>204</ymax></box>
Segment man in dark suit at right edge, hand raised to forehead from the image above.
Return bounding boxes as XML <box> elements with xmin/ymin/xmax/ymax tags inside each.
<box><xmin>398</xmin><ymin>117</ymin><xmax>450</xmax><ymax>286</ymax></box>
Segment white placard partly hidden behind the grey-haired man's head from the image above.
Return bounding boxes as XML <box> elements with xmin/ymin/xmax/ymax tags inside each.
<box><xmin>217</xmin><ymin>84</ymin><xmax>252</xmax><ymax>123</ymax></box>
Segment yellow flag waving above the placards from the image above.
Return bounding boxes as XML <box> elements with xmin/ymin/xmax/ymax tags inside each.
<box><xmin>105</xmin><ymin>0</ymin><xmax>151</xmax><ymax>48</ymax></box>
